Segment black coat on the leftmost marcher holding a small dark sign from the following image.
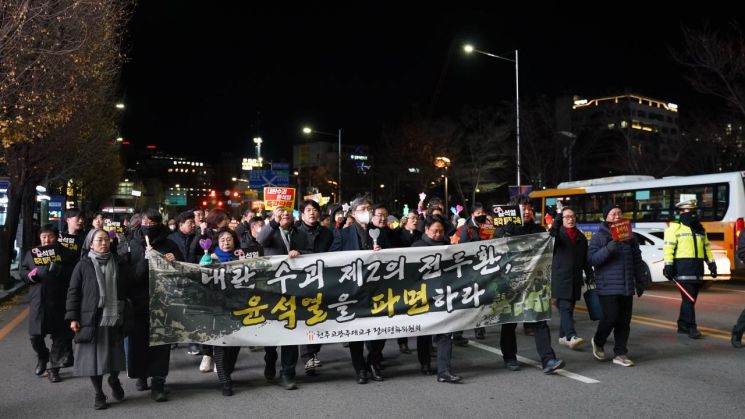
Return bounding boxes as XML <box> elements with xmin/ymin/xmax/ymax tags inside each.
<box><xmin>18</xmin><ymin>243</ymin><xmax>78</xmax><ymax>336</ymax></box>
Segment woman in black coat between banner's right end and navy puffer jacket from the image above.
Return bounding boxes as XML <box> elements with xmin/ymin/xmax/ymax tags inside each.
<box><xmin>548</xmin><ymin>207</ymin><xmax>594</xmax><ymax>349</ymax></box>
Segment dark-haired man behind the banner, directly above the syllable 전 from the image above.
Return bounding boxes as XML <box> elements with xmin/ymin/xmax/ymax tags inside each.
<box><xmin>411</xmin><ymin>215</ymin><xmax>461</xmax><ymax>383</ymax></box>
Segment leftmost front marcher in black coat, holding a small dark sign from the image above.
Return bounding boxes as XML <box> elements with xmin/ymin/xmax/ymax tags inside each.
<box><xmin>19</xmin><ymin>224</ymin><xmax>78</xmax><ymax>383</ymax></box>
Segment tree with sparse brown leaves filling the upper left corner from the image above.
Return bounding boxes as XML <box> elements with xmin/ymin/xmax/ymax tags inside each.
<box><xmin>0</xmin><ymin>0</ymin><xmax>130</xmax><ymax>283</ymax></box>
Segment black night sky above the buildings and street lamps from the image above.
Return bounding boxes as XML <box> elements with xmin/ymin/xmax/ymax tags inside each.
<box><xmin>121</xmin><ymin>1</ymin><xmax>745</xmax><ymax>162</ymax></box>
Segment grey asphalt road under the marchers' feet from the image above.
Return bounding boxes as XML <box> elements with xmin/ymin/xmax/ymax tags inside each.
<box><xmin>0</xmin><ymin>283</ymin><xmax>745</xmax><ymax>418</ymax></box>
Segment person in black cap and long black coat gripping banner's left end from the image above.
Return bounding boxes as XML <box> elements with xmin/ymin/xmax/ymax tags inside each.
<box><xmin>126</xmin><ymin>209</ymin><xmax>184</xmax><ymax>402</ymax></box>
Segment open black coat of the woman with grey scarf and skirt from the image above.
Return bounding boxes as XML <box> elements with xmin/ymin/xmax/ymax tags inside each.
<box><xmin>64</xmin><ymin>256</ymin><xmax>127</xmax><ymax>342</ymax></box>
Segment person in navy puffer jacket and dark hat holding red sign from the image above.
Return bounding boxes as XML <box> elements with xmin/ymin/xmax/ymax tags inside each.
<box><xmin>587</xmin><ymin>204</ymin><xmax>644</xmax><ymax>367</ymax></box>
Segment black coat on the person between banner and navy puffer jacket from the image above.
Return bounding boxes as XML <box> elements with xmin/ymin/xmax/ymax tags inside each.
<box><xmin>548</xmin><ymin>227</ymin><xmax>595</xmax><ymax>301</ymax></box>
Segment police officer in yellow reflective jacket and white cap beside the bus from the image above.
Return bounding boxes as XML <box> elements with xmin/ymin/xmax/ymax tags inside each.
<box><xmin>662</xmin><ymin>199</ymin><xmax>717</xmax><ymax>339</ymax></box>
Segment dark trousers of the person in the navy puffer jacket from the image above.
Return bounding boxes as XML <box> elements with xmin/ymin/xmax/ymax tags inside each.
<box><xmin>593</xmin><ymin>295</ymin><xmax>634</xmax><ymax>356</ymax></box>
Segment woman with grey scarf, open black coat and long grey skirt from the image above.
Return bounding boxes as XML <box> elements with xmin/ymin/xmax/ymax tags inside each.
<box><xmin>65</xmin><ymin>229</ymin><xmax>126</xmax><ymax>410</ymax></box>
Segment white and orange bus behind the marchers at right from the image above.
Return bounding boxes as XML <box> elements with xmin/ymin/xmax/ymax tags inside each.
<box><xmin>530</xmin><ymin>172</ymin><xmax>745</xmax><ymax>271</ymax></box>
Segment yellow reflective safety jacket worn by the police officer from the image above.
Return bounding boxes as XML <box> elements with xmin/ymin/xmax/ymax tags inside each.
<box><xmin>663</xmin><ymin>221</ymin><xmax>714</xmax><ymax>281</ymax></box>
